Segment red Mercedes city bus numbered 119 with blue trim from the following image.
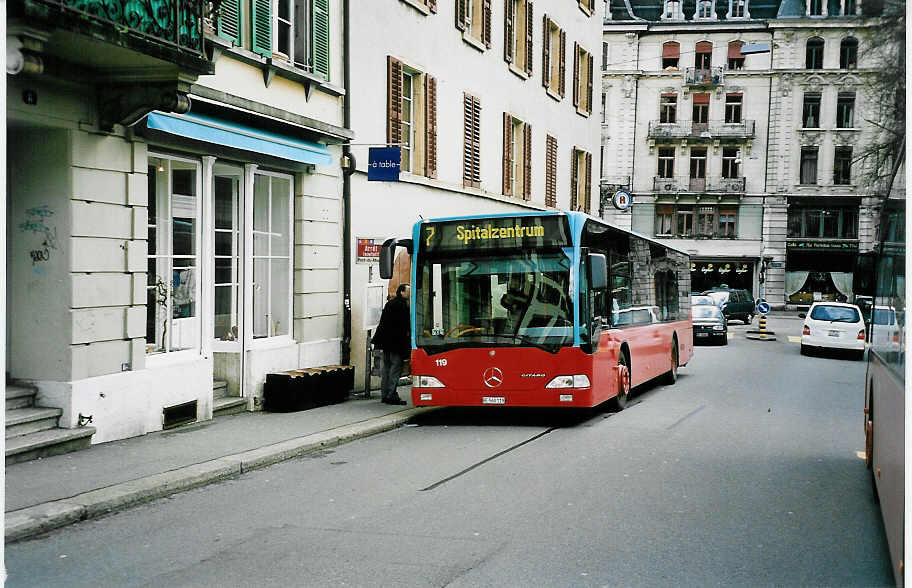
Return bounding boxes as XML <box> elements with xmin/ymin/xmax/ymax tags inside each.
<box><xmin>381</xmin><ymin>212</ymin><xmax>693</xmax><ymax>408</ymax></box>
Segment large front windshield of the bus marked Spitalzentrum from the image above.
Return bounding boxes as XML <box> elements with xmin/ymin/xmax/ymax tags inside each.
<box><xmin>415</xmin><ymin>250</ymin><xmax>573</xmax><ymax>353</ymax></box>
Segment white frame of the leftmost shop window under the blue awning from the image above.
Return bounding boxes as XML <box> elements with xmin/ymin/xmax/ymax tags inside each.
<box><xmin>144</xmin><ymin>151</ymin><xmax>208</xmax><ymax>367</ymax></box>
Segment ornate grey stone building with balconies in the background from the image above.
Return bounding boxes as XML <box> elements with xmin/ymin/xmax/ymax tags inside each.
<box><xmin>601</xmin><ymin>0</ymin><xmax>881</xmax><ymax>308</ymax></box>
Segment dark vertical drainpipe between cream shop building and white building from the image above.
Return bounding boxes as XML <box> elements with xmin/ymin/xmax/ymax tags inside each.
<box><xmin>341</xmin><ymin>0</ymin><xmax>355</xmax><ymax>365</ymax></box>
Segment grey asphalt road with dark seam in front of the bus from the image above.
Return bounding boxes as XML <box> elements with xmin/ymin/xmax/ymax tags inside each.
<box><xmin>6</xmin><ymin>319</ymin><xmax>893</xmax><ymax>586</ymax></box>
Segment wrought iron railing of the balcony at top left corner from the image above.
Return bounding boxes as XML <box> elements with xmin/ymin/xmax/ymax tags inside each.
<box><xmin>25</xmin><ymin>0</ymin><xmax>208</xmax><ymax>57</ymax></box>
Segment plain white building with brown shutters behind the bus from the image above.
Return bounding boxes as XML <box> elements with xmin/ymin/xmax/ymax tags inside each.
<box><xmin>350</xmin><ymin>0</ymin><xmax>604</xmax><ymax>387</ymax></box>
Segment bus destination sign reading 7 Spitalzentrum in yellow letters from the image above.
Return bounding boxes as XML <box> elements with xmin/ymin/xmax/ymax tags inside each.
<box><xmin>421</xmin><ymin>215</ymin><xmax>570</xmax><ymax>251</ymax></box>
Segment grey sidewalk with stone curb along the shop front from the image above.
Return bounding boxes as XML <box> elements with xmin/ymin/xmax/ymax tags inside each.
<box><xmin>5</xmin><ymin>386</ymin><xmax>434</xmax><ymax>542</ymax></box>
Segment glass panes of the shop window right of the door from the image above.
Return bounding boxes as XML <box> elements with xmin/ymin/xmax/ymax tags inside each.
<box><xmin>253</xmin><ymin>172</ymin><xmax>293</xmax><ymax>339</ymax></box>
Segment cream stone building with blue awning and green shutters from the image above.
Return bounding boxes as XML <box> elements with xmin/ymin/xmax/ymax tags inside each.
<box><xmin>6</xmin><ymin>0</ymin><xmax>353</xmax><ymax>443</ymax></box>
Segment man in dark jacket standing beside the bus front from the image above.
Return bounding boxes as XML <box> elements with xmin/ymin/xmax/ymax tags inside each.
<box><xmin>371</xmin><ymin>284</ymin><xmax>412</xmax><ymax>405</ymax></box>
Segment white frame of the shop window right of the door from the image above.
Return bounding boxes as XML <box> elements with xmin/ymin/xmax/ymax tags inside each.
<box><xmin>244</xmin><ymin>166</ymin><xmax>295</xmax><ymax>349</ymax></box>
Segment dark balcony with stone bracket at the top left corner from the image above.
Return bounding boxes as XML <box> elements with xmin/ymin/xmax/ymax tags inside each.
<box><xmin>7</xmin><ymin>0</ymin><xmax>215</xmax><ymax>130</ymax></box>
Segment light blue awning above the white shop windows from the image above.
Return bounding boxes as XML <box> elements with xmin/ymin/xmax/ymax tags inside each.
<box><xmin>146</xmin><ymin>112</ymin><xmax>332</xmax><ymax>165</ymax></box>
